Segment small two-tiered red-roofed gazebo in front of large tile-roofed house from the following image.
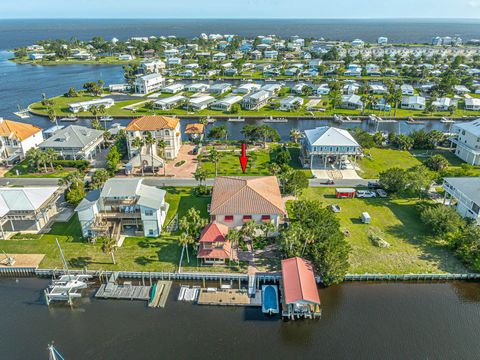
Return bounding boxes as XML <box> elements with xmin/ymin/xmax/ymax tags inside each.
<box><xmin>197</xmin><ymin>222</ymin><xmax>237</xmax><ymax>265</ymax></box>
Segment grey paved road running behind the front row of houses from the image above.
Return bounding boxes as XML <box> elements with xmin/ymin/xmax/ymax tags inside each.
<box><xmin>0</xmin><ymin>177</ymin><xmax>375</xmax><ymax>187</ymax></box>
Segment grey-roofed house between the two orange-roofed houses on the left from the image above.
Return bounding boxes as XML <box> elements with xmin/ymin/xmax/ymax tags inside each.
<box><xmin>38</xmin><ymin>125</ymin><xmax>104</xmax><ymax>160</ymax></box>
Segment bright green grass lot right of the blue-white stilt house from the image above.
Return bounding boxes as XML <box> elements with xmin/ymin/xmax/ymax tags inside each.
<box><xmin>358</xmin><ymin>148</ymin><xmax>480</xmax><ymax>179</ymax></box>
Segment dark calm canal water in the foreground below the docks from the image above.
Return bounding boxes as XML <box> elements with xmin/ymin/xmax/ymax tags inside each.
<box><xmin>0</xmin><ymin>279</ymin><xmax>480</xmax><ymax>360</ymax></box>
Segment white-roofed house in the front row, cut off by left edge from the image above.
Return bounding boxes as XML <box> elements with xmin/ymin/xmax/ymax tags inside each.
<box><xmin>0</xmin><ymin>186</ymin><xmax>61</xmax><ymax>239</ymax></box>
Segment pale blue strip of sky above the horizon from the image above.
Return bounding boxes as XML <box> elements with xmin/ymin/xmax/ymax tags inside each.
<box><xmin>0</xmin><ymin>0</ymin><xmax>480</xmax><ymax>19</ymax></box>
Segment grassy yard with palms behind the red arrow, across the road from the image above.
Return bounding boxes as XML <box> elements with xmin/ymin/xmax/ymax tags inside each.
<box><xmin>200</xmin><ymin>145</ymin><xmax>312</xmax><ymax>177</ymax></box>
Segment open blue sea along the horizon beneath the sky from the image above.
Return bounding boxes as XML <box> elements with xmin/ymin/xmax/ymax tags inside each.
<box><xmin>0</xmin><ymin>19</ymin><xmax>480</xmax><ymax>49</ymax></box>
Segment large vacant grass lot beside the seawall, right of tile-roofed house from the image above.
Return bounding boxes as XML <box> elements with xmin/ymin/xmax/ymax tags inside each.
<box><xmin>303</xmin><ymin>188</ymin><xmax>466</xmax><ymax>274</ymax></box>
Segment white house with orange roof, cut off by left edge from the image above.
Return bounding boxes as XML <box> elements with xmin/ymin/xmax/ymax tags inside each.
<box><xmin>0</xmin><ymin>117</ymin><xmax>43</xmax><ymax>164</ymax></box>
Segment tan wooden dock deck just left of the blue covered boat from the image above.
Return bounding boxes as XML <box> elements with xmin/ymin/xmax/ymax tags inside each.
<box><xmin>197</xmin><ymin>288</ymin><xmax>262</xmax><ymax>306</ymax></box>
